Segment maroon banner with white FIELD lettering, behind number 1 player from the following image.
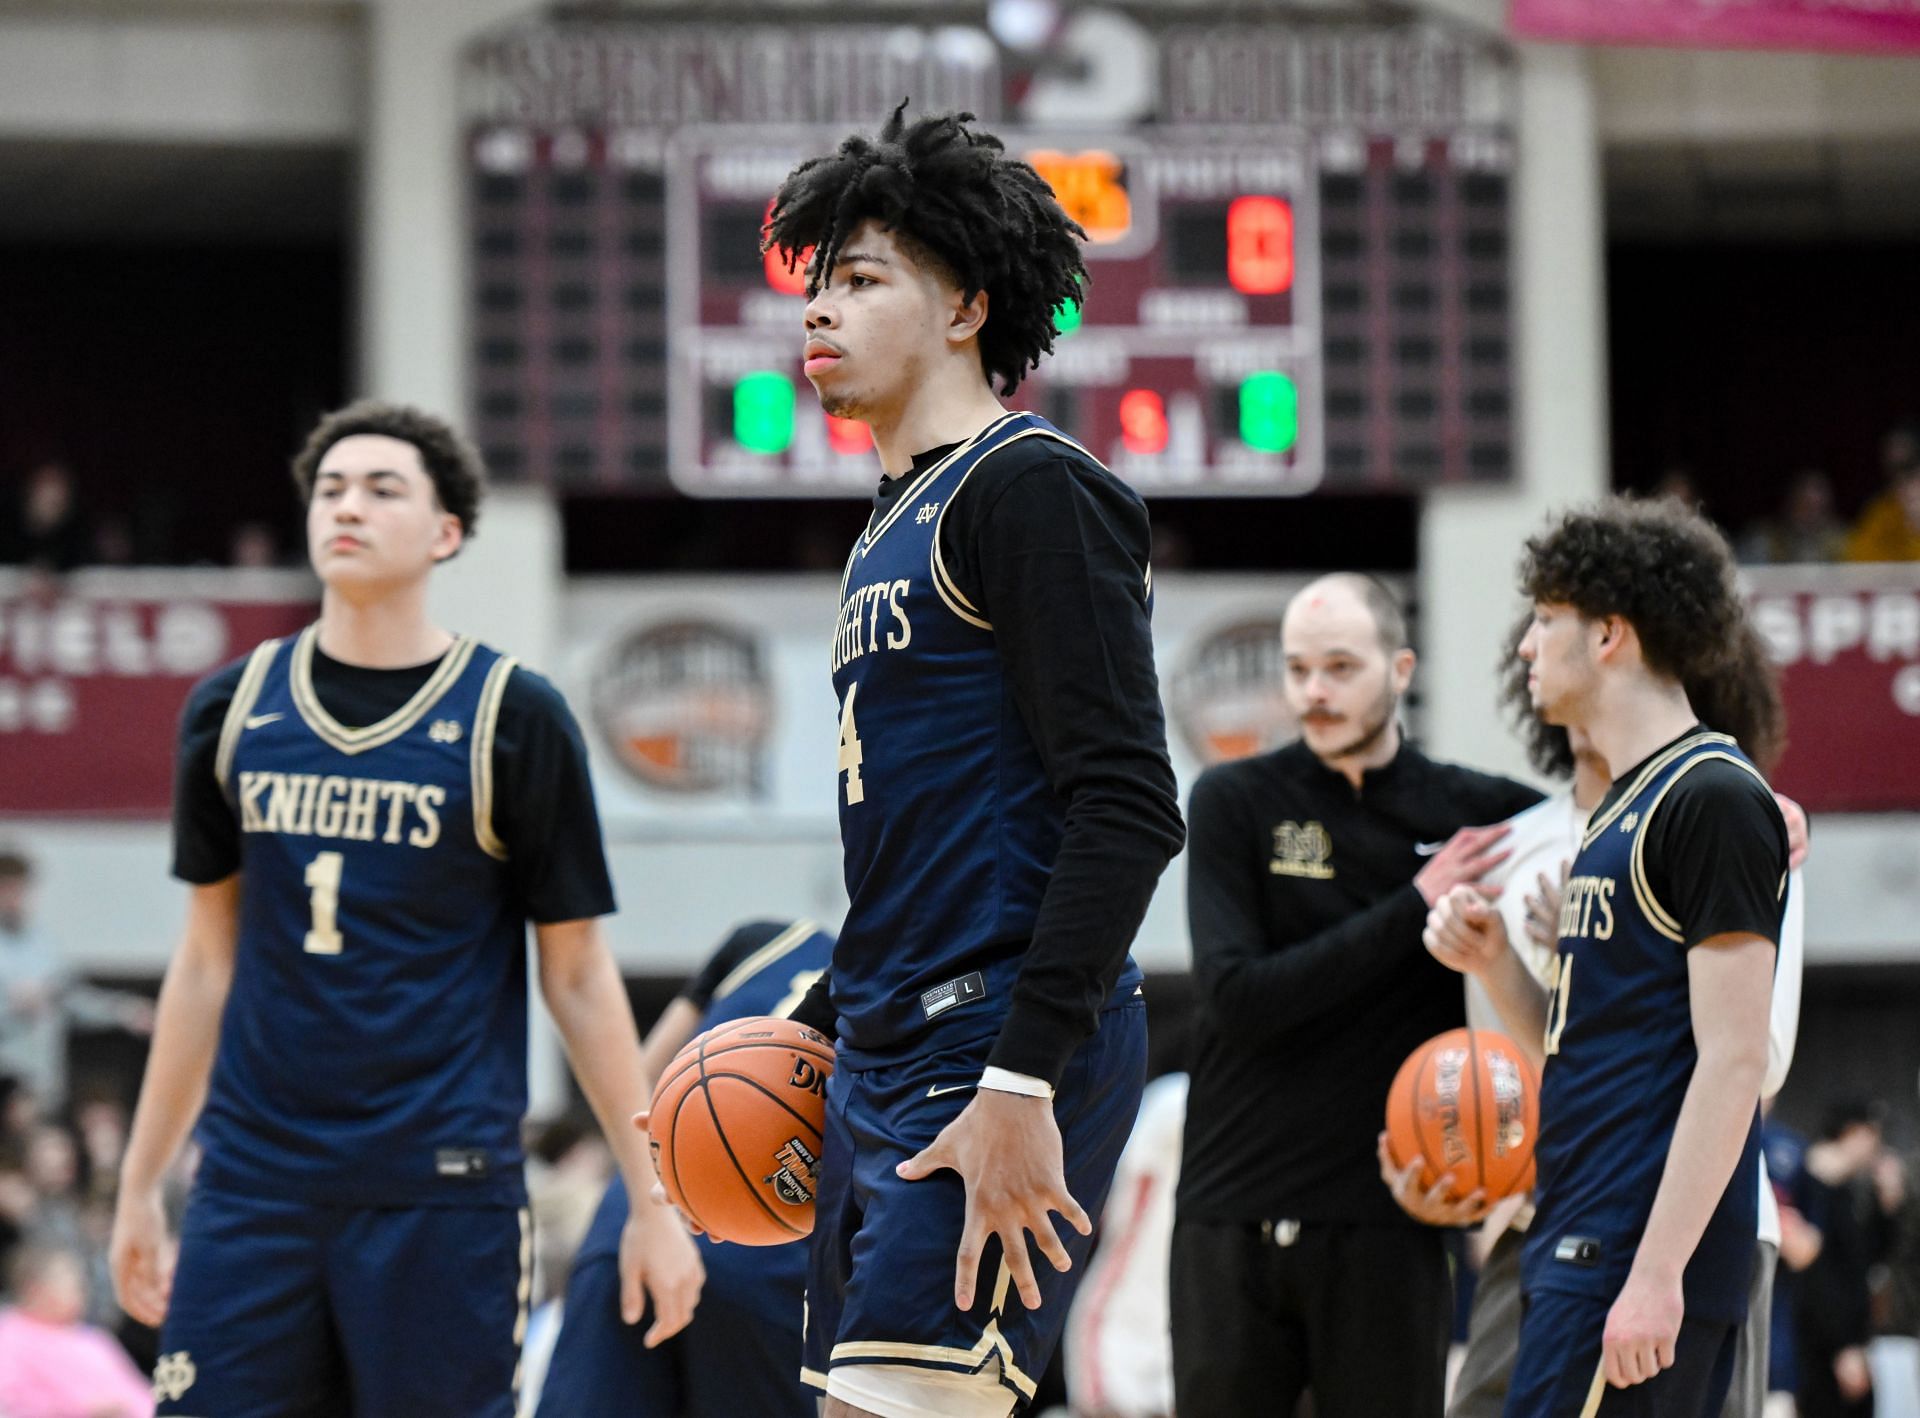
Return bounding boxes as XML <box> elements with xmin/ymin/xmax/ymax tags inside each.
<box><xmin>0</xmin><ymin>572</ymin><xmax>315</xmax><ymax>817</ymax></box>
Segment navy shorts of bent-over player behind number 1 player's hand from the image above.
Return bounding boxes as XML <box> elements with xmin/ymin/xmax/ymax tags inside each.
<box><xmin>538</xmin><ymin>1241</ymin><xmax>818</xmax><ymax>1418</ymax></box>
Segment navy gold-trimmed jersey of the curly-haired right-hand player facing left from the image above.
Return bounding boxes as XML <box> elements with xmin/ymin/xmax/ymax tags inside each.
<box><xmin>1524</xmin><ymin>729</ymin><xmax>1786</xmax><ymax>1322</ymax></box>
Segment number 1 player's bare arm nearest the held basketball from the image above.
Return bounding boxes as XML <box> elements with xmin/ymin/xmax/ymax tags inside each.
<box><xmin>536</xmin><ymin>921</ymin><xmax>707</xmax><ymax>1347</ymax></box>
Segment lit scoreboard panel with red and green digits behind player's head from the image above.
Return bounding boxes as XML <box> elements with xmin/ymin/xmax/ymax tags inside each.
<box><xmin>666</xmin><ymin>130</ymin><xmax>1323</xmax><ymax>495</ymax></box>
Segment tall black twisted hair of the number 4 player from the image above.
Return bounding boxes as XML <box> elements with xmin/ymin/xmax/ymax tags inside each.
<box><xmin>762</xmin><ymin>104</ymin><xmax>1087</xmax><ymax>393</ymax></box>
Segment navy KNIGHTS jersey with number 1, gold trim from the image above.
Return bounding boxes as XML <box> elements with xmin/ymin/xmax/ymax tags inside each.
<box><xmin>198</xmin><ymin>627</ymin><xmax>526</xmax><ymax>1205</ymax></box>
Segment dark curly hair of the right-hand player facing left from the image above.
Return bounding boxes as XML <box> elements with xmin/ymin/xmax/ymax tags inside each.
<box><xmin>1521</xmin><ymin>497</ymin><xmax>1747</xmax><ymax>683</ymax></box>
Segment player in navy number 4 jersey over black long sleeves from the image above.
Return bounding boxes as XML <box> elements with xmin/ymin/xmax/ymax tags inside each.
<box><xmin>744</xmin><ymin>104</ymin><xmax>1183</xmax><ymax>1418</ymax></box>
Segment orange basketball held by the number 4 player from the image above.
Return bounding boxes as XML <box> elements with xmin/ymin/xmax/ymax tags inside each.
<box><xmin>649</xmin><ymin>1017</ymin><xmax>833</xmax><ymax>1245</ymax></box>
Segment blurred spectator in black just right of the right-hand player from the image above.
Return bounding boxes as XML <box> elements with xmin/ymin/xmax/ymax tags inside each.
<box><xmin>1791</xmin><ymin>1099</ymin><xmax>1882</xmax><ymax>1418</ymax></box>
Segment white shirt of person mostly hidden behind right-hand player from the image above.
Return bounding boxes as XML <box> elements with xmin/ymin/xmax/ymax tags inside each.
<box><xmin>1467</xmin><ymin>787</ymin><xmax>1807</xmax><ymax>1245</ymax></box>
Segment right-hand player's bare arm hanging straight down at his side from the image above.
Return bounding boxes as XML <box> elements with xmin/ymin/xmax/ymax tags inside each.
<box><xmin>1603</xmin><ymin>934</ymin><xmax>1774</xmax><ymax>1387</ymax></box>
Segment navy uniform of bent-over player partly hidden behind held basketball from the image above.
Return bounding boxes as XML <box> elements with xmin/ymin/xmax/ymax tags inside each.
<box><xmin>540</xmin><ymin>921</ymin><xmax>833</xmax><ymax>1418</ymax></box>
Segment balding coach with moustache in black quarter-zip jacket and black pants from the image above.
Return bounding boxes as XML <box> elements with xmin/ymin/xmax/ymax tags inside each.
<box><xmin>1171</xmin><ymin>574</ymin><xmax>1540</xmax><ymax>1418</ymax></box>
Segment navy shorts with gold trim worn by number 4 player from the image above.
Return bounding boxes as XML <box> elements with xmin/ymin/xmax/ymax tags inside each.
<box><xmin>803</xmin><ymin>1000</ymin><xmax>1146</xmax><ymax>1408</ymax></box>
